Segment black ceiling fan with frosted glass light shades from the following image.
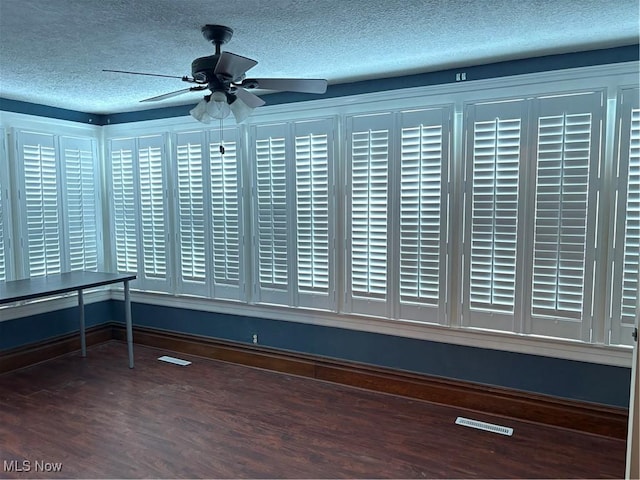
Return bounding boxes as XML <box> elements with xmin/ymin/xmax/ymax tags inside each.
<box><xmin>103</xmin><ymin>25</ymin><xmax>327</xmax><ymax>123</ymax></box>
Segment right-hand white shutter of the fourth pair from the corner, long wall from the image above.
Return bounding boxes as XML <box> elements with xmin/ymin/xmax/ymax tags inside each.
<box><xmin>399</xmin><ymin>108</ymin><xmax>451</xmax><ymax>322</ymax></box>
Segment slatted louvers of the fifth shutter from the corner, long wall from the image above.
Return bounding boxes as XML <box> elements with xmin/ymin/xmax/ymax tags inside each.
<box><xmin>255</xmin><ymin>137</ymin><xmax>289</xmax><ymax>290</ymax></box>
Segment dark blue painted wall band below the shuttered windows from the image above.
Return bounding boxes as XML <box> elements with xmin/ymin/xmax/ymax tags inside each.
<box><xmin>0</xmin><ymin>300</ymin><xmax>631</xmax><ymax>408</ymax></box>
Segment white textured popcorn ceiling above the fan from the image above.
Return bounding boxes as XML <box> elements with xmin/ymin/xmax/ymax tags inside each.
<box><xmin>0</xmin><ymin>0</ymin><xmax>639</xmax><ymax>113</ymax></box>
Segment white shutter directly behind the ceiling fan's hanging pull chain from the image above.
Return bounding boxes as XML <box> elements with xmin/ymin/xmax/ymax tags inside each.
<box><xmin>209</xmin><ymin>128</ymin><xmax>245</xmax><ymax>300</ymax></box>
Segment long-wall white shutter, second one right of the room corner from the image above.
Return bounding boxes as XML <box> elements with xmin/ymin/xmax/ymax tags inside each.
<box><xmin>137</xmin><ymin>135</ymin><xmax>169</xmax><ymax>291</ymax></box>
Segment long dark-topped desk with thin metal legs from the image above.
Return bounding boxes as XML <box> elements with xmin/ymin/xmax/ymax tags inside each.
<box><xmin>0</xmin><ymin>272</ymin><xmax>136</xmax><ymax>368</ymax></box>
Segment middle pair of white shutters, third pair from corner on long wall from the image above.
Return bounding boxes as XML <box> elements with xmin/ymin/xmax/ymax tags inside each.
<box><xmin>250</xmin><ymin>119</ymin><xmax>336</xmax><ymax>310</ymax></box>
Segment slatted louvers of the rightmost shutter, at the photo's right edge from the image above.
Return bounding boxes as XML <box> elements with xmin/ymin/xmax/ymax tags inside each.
<box><xmin>621</xmin><ymin>108</ymin><xmax>640</xmax><ymax>326</ymax></box>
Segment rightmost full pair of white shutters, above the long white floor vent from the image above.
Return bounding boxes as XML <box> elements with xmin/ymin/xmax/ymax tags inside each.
<box><xmin>464</xmin><ymin>92</ymin><xmax>603</xmax><ymax>339</ymax></box>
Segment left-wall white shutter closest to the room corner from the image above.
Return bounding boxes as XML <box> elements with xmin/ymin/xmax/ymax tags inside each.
<box><xmin>60</xmin><ymin>137</ymin><xmax>98</xmax><ymax>271</ymax></box>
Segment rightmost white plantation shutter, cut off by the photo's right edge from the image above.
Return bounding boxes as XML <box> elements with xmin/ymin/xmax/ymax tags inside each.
<box><xmin>609</xmin><ymin>88</ymin><xmax>640</xmax><ymax>345</ymax></box>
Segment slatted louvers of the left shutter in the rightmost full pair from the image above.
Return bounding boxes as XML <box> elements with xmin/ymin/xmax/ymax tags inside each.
<box><xmin>469</xmin><ymin>118</ymin><xmax>521</xmax><ymax>312</ymax></box>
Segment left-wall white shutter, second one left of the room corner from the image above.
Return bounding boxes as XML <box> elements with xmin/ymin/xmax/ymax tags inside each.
<box><xmin>17</xmin><ymin>131</ymin><xmax>62</xmax><ymax>277</ymax></box>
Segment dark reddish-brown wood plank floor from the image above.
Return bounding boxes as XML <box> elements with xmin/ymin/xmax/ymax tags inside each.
<box><xmin>0</xmin><ymin>341</ymin><xmax>625</xmax><ymax>478</ymax></box>
